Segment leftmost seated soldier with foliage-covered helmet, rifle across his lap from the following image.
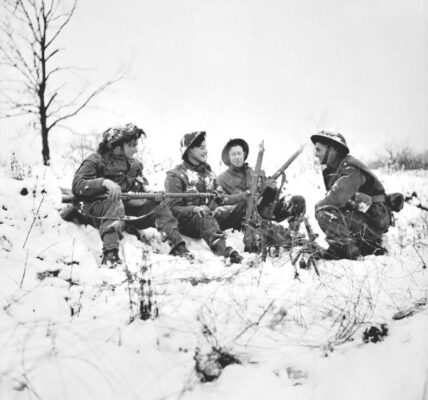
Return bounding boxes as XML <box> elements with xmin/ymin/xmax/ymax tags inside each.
<box><xmin>72</xmin><ymin>124</ymin><xmax>190</xmax><ymax>268</ymax></box>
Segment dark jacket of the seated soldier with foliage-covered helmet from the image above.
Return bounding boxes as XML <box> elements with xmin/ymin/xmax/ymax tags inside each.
<box><xmin>72</xmin><ymin>153</ymin><xmax>148</xmax><ymax>197</ymax></box>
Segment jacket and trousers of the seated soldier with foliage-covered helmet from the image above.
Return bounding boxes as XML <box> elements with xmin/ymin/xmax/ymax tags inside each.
<box><xmin>72</xmin><ymin>123</ymin><xmax>183</xmax><ymax>258</ymax></box>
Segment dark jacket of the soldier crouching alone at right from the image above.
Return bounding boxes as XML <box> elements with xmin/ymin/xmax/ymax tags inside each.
<box><xmin>317</xmin><ymin>155</ymin><xmax>385</xmax><ymax>208</ymax></box>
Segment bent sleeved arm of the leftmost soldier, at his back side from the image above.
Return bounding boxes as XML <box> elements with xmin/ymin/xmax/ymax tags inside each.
<box><xmin>72</xmin><ymin>156</ymin><xmax>106</xmax><ymax>197</ymax></box>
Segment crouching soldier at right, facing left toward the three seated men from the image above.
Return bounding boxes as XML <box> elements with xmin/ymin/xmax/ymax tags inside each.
<box><xmin>311</xmin><ymin>131</ymin><xmax>391</xmax><ymax>259</ymax></box>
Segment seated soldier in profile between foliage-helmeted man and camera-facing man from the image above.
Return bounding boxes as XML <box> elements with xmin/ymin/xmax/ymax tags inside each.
<box><xmin>165</xmin><ymin>131</ymin><xmax>245</xmax><ymax>263</ymax></box>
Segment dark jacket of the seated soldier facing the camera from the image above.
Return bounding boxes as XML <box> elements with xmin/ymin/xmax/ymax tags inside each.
<box><xmin>217</xmin><ymin>163</ymin><xmax>265</xmax><ymax>194</ymax></box>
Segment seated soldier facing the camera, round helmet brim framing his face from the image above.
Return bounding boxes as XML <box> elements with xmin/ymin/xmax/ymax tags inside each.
<box><xmin>217</xmin><ymin>139</ymin><xmax>306</xmax><ymax>251</ymax></box>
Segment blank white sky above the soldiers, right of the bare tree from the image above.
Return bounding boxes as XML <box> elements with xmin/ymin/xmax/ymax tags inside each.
<box><xmin>0</xmin><ymin>0</ymin><xmax>428</xmax><ymax>167</ymax></box>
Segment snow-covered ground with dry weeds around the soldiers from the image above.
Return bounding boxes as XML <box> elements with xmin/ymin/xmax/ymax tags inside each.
<box><xmin>0</xmin><ymin>156</ymin><xmax>428</xmax><ymax>400</ymax></box>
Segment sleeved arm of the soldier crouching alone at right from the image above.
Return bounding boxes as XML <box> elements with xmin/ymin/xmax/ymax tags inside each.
<box><xmin>316</xmin><ymin>165</ymin><xmax>366</xmax><ymax>208</ymax></box>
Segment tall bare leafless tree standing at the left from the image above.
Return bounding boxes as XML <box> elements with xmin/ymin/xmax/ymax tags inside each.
<box><xmin>0</xmin><ymin>0</ymin><xmax>121</xmax><ymax>165</ymax></box>
